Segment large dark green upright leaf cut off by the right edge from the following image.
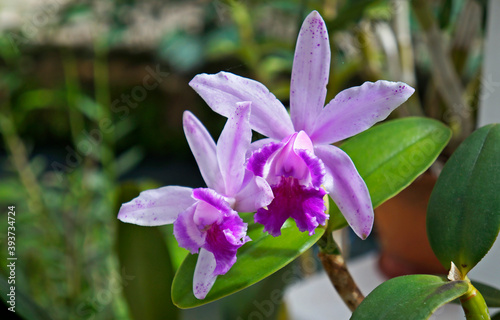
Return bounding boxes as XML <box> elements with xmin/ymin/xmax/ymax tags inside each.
<box><xmin>427</xmin><ymin>124</ymin><xmax>500</xmax><ymax>275</ymax></box>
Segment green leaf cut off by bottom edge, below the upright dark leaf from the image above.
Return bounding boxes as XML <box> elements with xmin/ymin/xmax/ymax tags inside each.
<box><xmin>351</xmin><ymin>275</ymin><xmax>468</xmax><ymax>320</ymax></box>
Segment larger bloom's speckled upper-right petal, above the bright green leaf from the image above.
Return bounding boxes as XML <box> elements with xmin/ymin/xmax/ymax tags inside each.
<box><xmin>309</xmin><ymin>80</ymin><xmax>415</xmax><ymax>144</ymax></box>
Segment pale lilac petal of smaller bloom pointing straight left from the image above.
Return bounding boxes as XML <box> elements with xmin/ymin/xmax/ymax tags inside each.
<box><xmin>118</xmin><ymin>186</ymin><xmax>195</xmax><ymax>226</ymax></box>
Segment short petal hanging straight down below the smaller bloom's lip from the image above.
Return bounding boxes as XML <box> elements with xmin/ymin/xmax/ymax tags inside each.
<box><xmin>193</xmin><ymin>248</ymin><xmax>217</xmax><ymax>299</ymax></box>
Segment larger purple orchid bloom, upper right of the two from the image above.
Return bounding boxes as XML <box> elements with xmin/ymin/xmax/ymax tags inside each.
<box><xmin>190</xmin><ymin>11</ymin><xmax>414</xmax><ymax>239</ymax></box>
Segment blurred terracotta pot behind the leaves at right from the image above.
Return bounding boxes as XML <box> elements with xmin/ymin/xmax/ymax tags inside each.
<box><xmin>375</xmin><ymin>173</ymin><xmax>447</xmax><ymax>278</ymax></box>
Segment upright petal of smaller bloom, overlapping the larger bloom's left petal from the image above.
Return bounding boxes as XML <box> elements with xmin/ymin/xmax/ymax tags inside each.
<box><xmin>217</xmin><ymin>102</ymin><xmax>252</xmax><ymax>197</ymax></box>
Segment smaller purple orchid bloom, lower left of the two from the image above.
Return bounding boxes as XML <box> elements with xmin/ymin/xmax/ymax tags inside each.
<box><xmin>118</xmin><ymin>102</ymin><xmax>273</xmax><ymax>299</ymax></box>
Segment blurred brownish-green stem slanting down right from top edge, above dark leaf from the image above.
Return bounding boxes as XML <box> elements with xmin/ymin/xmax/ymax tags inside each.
<box><xmin>411</xmin><ymin>0</ymin><xmax>473</xmax><ymax>149</ymax></box>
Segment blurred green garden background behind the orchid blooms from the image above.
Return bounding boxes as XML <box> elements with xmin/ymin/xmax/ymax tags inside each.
<box><xmin>0</xmin><ymin>0</ymin><xmax>487</xmax><ymax>319</ymax></box>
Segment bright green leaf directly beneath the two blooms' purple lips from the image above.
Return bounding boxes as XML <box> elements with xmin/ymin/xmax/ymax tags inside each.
<box><xmin>172</xmin><ymin>214</ymin><xmax>324</xmax><ymax>308</ymax></box>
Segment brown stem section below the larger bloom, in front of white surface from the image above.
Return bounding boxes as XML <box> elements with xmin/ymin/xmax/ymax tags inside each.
<box><xmin>318</xmin><ymin>231</ymin><xmax>365</xmax><ymax>311</ymax></box>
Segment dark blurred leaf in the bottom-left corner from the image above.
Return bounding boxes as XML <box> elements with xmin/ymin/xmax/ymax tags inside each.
<box><xmin>0</xmin><ymin>274</ymin><xmax>52</xmax><ymax>320</ymax></box>
